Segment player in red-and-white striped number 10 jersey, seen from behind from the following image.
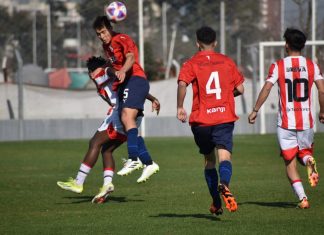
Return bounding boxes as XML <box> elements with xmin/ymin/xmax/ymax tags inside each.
<box><xmin>249</xmin><ymin>28</ymin><xmax>324</xmax><ymax>209</ymax></box>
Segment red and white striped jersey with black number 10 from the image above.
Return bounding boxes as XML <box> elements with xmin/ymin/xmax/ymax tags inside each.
<box><xmin>267</xmin><ymin>56</ymin><xmax>323</xmax><ymax>130</ymax></box>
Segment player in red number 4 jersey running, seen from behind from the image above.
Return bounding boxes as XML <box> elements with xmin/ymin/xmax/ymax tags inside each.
<box><xmin>177</xmin><ymin>27</ymin><xmax>244</xmax><ymax>215</ymax></box>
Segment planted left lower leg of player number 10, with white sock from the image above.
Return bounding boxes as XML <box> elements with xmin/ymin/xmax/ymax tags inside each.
<box><xmin>285</xmin><ymin>158</ymin><xmax>309</xmax><ymax>209</ymax></box>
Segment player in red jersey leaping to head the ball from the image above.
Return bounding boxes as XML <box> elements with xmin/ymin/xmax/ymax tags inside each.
<box><xmin>93</xmin><ymin>16</ymin><xmax>159</xmax><ymax>179</ymax></box>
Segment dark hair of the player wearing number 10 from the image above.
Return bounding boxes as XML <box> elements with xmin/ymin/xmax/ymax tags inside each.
<box><xmin>284</xmin><ymin>28</ymin><xmax>307</xmax><ymax>51</ymax></box>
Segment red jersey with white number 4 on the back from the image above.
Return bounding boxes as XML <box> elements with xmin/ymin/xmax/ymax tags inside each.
<box><xmin>178</xmin><ymin>51</ymin><xmax>244</xmax><ymax>126</ymax></box>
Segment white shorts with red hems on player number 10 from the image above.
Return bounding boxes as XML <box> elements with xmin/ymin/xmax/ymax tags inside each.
<box><xmin>277</xmin><ymin>127</ymin><xmax>314</xmax><ymax>161</ymax></box>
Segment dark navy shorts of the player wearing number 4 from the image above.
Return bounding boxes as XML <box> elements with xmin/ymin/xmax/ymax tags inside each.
<box><xmin>191</xmin><ymin>122</ymin><xmax>234</xmax><ymax>155</ymax></box>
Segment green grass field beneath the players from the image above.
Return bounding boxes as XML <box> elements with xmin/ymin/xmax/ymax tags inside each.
<box><xmin>0</xmin><ymin>134</ymin><xmax>324</xmax><ymax>235</ymax></box>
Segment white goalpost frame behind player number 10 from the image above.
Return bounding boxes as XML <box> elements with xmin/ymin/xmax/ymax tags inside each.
<box><xmin>253</xmin><ymin>40</ymin><xmax>324</xmax><ymax>134</ymax></box>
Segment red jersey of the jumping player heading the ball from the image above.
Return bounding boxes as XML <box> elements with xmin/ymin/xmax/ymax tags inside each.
<box><xmin>103</xmin><ymin>33</ymin><xmax>146</xmax><ymax>78</ymax></box>
